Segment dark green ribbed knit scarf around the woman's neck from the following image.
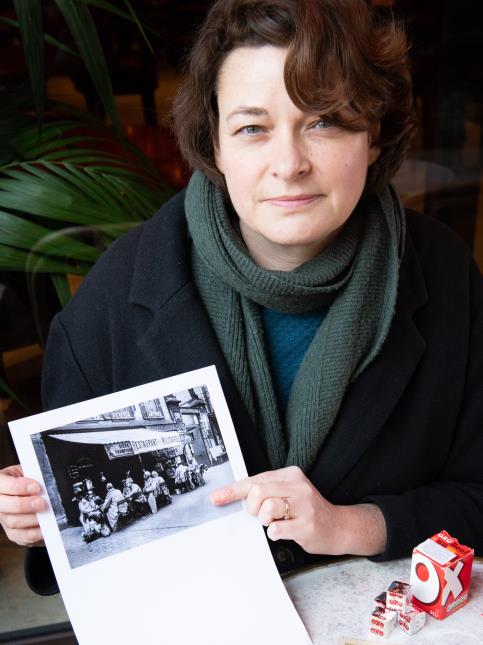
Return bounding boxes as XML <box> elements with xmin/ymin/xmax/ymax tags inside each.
<box><xmin>185</xmin><ymin>172</ymin><xmax>405</xmax><ymax>471</ymax></box>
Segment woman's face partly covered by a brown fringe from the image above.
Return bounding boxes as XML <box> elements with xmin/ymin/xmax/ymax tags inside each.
<box><xmin>215</xmin><ymin>46</ymin><xmax>379</xmax><ymax>270</ymax></box>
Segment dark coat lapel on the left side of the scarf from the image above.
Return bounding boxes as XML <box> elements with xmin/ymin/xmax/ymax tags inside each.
<box><xmin>129</xmin><ymin>193</ymin><xmax>268</xmax><ymax>474</ymax></box>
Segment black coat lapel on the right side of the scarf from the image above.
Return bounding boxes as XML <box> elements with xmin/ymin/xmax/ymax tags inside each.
<box><xmin>310</xmin><ymin>231</ymin><xmax>427</xmax><ymax>496</ymax></box>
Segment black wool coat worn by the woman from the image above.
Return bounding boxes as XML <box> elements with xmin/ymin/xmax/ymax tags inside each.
<box><xmin>27</xmin><ymin>187</ymin><xmax>483</xmax><ymax>586</ymax></box>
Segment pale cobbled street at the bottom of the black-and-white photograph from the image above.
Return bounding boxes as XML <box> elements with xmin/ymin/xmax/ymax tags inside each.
<box><xmin>61</xmin><ymin>462</ymin><xmax>241</xmax><ymax>568</ymax></box>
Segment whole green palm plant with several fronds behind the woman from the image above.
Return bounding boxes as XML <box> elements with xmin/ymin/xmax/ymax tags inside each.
<box><xmin>0</xmin><ymin>0</ymin><xmax>173</xmax><ymax>397</ymax></box>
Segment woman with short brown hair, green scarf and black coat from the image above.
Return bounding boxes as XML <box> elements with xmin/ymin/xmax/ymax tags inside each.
<box><xmin>0</xmin><ymin>0</ymin><xmax>483</xmax><ymax>591</ymax></box>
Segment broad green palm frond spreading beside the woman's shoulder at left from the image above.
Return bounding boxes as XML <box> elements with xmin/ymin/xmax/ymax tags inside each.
<box><xmin>0</xmin><ymin>121</ymin><xmax>173</xmax><ymax>303</ymax></box>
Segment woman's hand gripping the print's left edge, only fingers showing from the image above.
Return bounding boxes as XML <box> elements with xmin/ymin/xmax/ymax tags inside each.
<box><xmin>0</xmin><ymin>465</ymin><xmax>46</xmax><ymax>546</ymax></box>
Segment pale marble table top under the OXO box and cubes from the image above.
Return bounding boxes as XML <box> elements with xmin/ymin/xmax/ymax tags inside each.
<box><xmin>284</xmin><ymin>558</ymin><xmax>483</xmax><ymax>645</ymax></box>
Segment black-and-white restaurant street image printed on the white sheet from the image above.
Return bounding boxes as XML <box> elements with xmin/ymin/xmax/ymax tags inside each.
<box><xmin>31</xmin><ymin>385</ymin><xmax>242</xmax><ymax>568</ymax></box>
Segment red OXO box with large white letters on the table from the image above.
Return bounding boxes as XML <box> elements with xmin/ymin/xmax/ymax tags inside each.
<box><xmin>410</xmin><ymin>531</ymin><xmax>474</xmax><ymax>620</ymax></box>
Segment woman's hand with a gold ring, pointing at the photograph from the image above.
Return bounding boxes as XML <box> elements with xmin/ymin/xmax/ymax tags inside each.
<box><xmin>211</xmin><ymin>466</ymin><xmax>387</xmax><ymax>555</ymax></box>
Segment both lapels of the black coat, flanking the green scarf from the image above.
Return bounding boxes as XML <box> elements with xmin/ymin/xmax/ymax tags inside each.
<box><xmin>129</xmin><ymin>191</ymin><xmax>427</xmax><ymax>494</ymax></box>
